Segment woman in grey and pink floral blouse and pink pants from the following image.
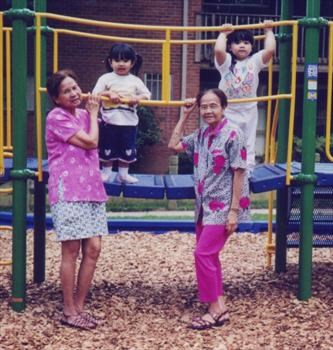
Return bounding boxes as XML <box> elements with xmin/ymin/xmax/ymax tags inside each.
<box><xmin>169</xmin><ymin>89</ymin><xmax>250</xmax><ymax>330</ymax></box>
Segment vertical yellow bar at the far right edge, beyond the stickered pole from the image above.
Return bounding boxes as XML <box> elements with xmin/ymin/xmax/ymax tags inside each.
<box><xmin>325</xmin><ymin>22</ymin><xmax>333</xmax><ymax>162</ymax></box>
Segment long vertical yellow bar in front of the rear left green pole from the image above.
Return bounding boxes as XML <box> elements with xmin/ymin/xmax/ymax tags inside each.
<box><xmin>35</xmin><ymin>12</ymin><xmax>43</xmax><ymax>182</ymax></box>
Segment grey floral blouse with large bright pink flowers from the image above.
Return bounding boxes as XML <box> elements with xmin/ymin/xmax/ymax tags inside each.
<box><xmin>181</xmin><ymin>118</ymin><xmax>250</xmax><ymax>225</ymax></box>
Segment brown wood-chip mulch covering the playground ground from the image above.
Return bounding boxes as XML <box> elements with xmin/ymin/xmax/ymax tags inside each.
<box><xmin>0</xmin><ymin>231</ymin><xmax>333</xmax><ymax>350</ymax></box>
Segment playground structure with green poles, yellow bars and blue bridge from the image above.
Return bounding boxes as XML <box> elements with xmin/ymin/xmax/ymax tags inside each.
<box><xmin>0</xmin><ymin>1</ymin><xmax>333</xmax><ymax>311</ymax></box>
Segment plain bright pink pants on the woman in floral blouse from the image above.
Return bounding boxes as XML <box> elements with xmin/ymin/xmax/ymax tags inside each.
<box><xmin>194</xmin><ymin>224</ymin><xmax>228</xmax><ymax>303</ymax></box>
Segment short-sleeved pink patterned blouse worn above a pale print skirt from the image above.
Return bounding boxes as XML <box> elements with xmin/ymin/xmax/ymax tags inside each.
<box><xmin>46</xmin><ymin>107</ymin><xmax>107</xmax><ymax>204</ymax></box>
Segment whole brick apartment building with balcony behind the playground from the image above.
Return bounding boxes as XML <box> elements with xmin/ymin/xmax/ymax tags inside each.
<box><xmin>0</xmin><ymin>0</ymin><xmax>333</xmax><ymax>173</ymax></box>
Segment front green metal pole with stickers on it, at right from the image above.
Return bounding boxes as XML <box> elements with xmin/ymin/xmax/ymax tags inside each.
<box><xmin>298</xmin><ymin>0</ymin><xmax>320</xmax><ymax>300</ymax></box>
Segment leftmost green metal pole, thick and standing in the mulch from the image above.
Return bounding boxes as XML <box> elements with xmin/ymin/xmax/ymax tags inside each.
<box><xmin>11</xmin><ymin>0</ymin><xmax>27</xmax><ymax>311</ymax></box>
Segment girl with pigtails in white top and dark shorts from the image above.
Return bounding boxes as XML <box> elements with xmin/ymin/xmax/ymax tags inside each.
<box><xmin>93</xmin><ymin>43</ymin><xmax>150</xmax><ymax>183</ymax></box>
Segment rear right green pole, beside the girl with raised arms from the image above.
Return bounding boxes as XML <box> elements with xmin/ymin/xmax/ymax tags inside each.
<box><xmin>275</xmin><ymin>0</ymin><xmax>293</xmax><ymax>272</ymax></box>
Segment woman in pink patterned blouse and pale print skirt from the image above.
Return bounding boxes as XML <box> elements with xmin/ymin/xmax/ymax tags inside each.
<box><xmin>46</xmin><ymin>70</ymin><xmax>108</xmax><ymax>329</ymax></box>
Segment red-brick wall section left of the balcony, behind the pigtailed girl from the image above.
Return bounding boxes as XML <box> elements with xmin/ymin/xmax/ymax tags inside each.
<box><xmin>48</xmin><ymin>0</ymin><xmax>201</xmax><ymax>173</ymax></box>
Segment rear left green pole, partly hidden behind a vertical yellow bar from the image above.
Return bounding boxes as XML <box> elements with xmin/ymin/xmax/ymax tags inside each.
<box><xmin>34</xmin><ymin>0</ymin><xmax>47</xmax><ymax>283</ymax></box>
